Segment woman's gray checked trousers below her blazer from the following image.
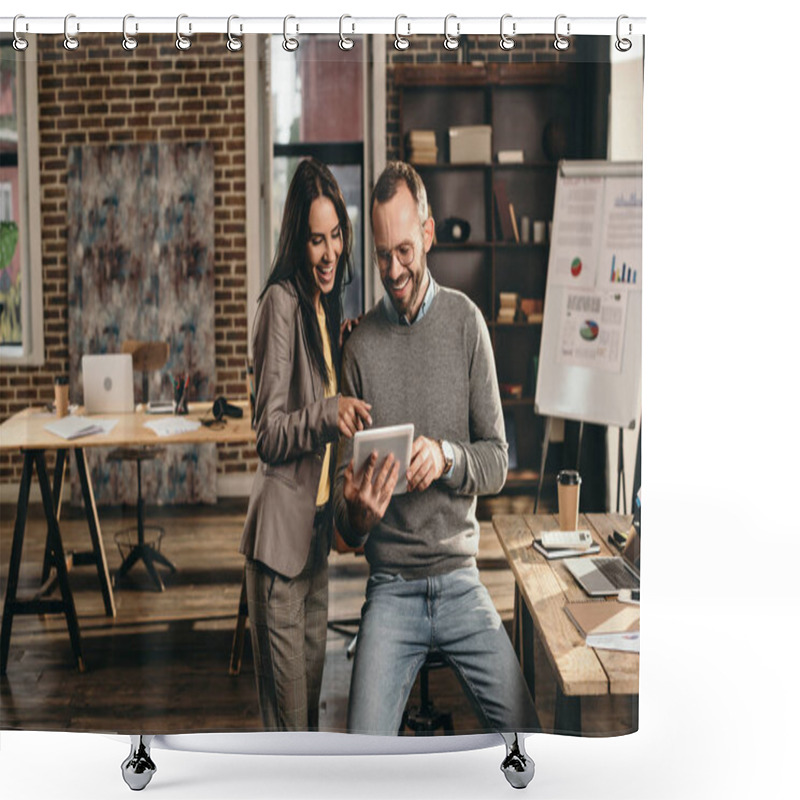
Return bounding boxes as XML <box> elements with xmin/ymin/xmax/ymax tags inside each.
<box><xmin>246</xmin><ymin>513</ymin><xmax>332</xmax><ymax>731</ymax></box>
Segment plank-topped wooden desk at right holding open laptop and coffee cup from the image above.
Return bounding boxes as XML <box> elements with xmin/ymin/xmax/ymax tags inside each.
<box><xmin>492</xmin><ymin>514</ymin><xmax>639</xmax><ymax>734</ymax></box>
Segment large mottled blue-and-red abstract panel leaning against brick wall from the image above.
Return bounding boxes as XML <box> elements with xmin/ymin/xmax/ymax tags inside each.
<box><xmin>67</xmin><ymin>143</ymin><xmax>217</xmax><ymax>504</ymax></box>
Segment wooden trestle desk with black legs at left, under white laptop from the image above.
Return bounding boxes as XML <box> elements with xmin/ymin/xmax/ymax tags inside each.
<box><xmin>0</xmin><ymin>401</ymin><xmax>255</xmax><ymax>675</ymax></box>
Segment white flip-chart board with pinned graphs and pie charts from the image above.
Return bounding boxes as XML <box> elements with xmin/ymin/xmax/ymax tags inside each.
<box><xmin>535</xmin><ymin>161</ymin><xmax>643</xmax><ymax>428</ymax></box>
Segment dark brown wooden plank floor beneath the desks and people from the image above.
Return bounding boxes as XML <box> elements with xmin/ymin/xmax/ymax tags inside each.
<box><xmin>0</xmin><ymin>500</ymin><xmax>628</xmax><ymax>733</ymax></box>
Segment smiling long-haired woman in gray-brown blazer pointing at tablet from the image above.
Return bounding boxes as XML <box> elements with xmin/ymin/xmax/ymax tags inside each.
<box><xmin>240</xmin><ymin>158</ymin><xmax>372</xmax><ymax>731</ymax></box>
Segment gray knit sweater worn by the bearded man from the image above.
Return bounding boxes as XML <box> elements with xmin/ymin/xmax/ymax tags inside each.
<box><xmin>334</xmin><ymin>287</ymin><xmax>508</xmax><ymax>580</ymax></box>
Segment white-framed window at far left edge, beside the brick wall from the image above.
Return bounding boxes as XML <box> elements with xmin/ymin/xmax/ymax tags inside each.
<box><xmin>0</xmin><ymin>37</ymin><xmax>44</xmax><ymax>364</ymax></box>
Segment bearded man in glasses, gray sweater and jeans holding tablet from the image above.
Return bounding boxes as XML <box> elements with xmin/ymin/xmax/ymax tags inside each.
<box><xmin>334</xmin><ymin>162</ymin><xmax>539</xmax><ymax>734</ymax></box>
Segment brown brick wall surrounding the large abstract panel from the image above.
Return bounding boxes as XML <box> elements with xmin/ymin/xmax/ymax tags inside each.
<box><xmin>0</xmin><ymin>34</ymin><xmax>255</xmax><ymax>484</ymax></box>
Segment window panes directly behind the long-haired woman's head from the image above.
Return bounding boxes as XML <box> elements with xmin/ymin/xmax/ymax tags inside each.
<box><xmin>268</xmin><ymin>36</ymin><xmax>365</xmax><ymax>317</ymax></box>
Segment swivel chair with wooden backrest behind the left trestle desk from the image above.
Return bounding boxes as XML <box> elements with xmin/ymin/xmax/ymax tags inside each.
<box><xmin>108</xmin><ymin>340</ymin><xmax>175</xmax><ymax>592</ymax></box>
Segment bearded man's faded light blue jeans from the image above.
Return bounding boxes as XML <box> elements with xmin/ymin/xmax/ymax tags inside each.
<box><xmin>347</xmin><ymin>567</ymin><xmax>539</xmax><ymax>734</ymax></box>
